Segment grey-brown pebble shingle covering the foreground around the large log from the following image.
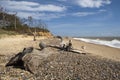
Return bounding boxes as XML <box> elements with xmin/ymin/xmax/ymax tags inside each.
<box><xmin>0</xmin><ymin>42</ymin><xmax>120</xmax><ymax>80</ymax></box>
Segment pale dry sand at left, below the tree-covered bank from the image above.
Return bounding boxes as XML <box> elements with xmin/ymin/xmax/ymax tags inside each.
<box><xmin>0</xmin><ymin>35</ymin><xmax>45</xmax><ymax>55</ymax></box>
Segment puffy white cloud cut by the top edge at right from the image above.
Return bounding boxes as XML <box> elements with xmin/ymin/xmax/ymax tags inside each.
<box><xmin>76</xmin><ymin>0</ymin><xmax>111</xmax><ymax>8</ymax></box>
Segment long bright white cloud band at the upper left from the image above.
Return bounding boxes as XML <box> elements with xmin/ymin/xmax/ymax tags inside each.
<box><xmin>0</xmin><ymin>1</ymin><xmax>66</xmax><ymax>12</ymax></box>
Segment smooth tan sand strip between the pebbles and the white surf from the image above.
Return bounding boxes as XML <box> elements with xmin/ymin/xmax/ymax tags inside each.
<box><xmin>72</xmin><ymin>39</ymin><xmax>120</xmax><ymax>61</ymax></box>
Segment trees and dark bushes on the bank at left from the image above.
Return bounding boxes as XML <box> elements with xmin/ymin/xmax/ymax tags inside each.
<box><xmin>0</xmin><ymin>7</ymin><xmax>49</xmax><ymax>34</ymax></box>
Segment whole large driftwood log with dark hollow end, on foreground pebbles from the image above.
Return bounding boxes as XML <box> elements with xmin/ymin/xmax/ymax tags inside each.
<box><xmin>6</xmin><ymin>47</ymin><xmax>53</xmax><ymax>74</ymax></box>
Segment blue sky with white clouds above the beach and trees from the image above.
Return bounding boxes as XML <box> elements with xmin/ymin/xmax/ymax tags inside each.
<box><xmin>0</xmin><ymin>0</ymin><xmax>120</xmax><ymax>37</ymax></box>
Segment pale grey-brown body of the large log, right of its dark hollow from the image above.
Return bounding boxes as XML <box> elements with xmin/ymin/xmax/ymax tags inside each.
<box><xmin>22</xmin><ymin>47</ymin><xmax>53</xmax><ymax>74</ymax></box>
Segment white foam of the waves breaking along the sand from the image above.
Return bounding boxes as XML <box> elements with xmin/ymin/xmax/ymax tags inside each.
<box><xmin>74</xmin><ymin>38</ymin><xmax>120</xmax><ymax>48</ymax></box>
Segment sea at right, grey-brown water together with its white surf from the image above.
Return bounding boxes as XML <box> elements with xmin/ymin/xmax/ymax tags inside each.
<box><xmin>74</xmin><ymin>37</ymin><xmax>120</xmax><ymax>48</ymax></box>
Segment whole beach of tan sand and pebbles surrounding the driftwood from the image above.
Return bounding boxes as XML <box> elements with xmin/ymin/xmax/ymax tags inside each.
<box><xmin>0</xmin><ymin>36</ymin><xmax>120</xmax><ymax>80</ymax></box>
